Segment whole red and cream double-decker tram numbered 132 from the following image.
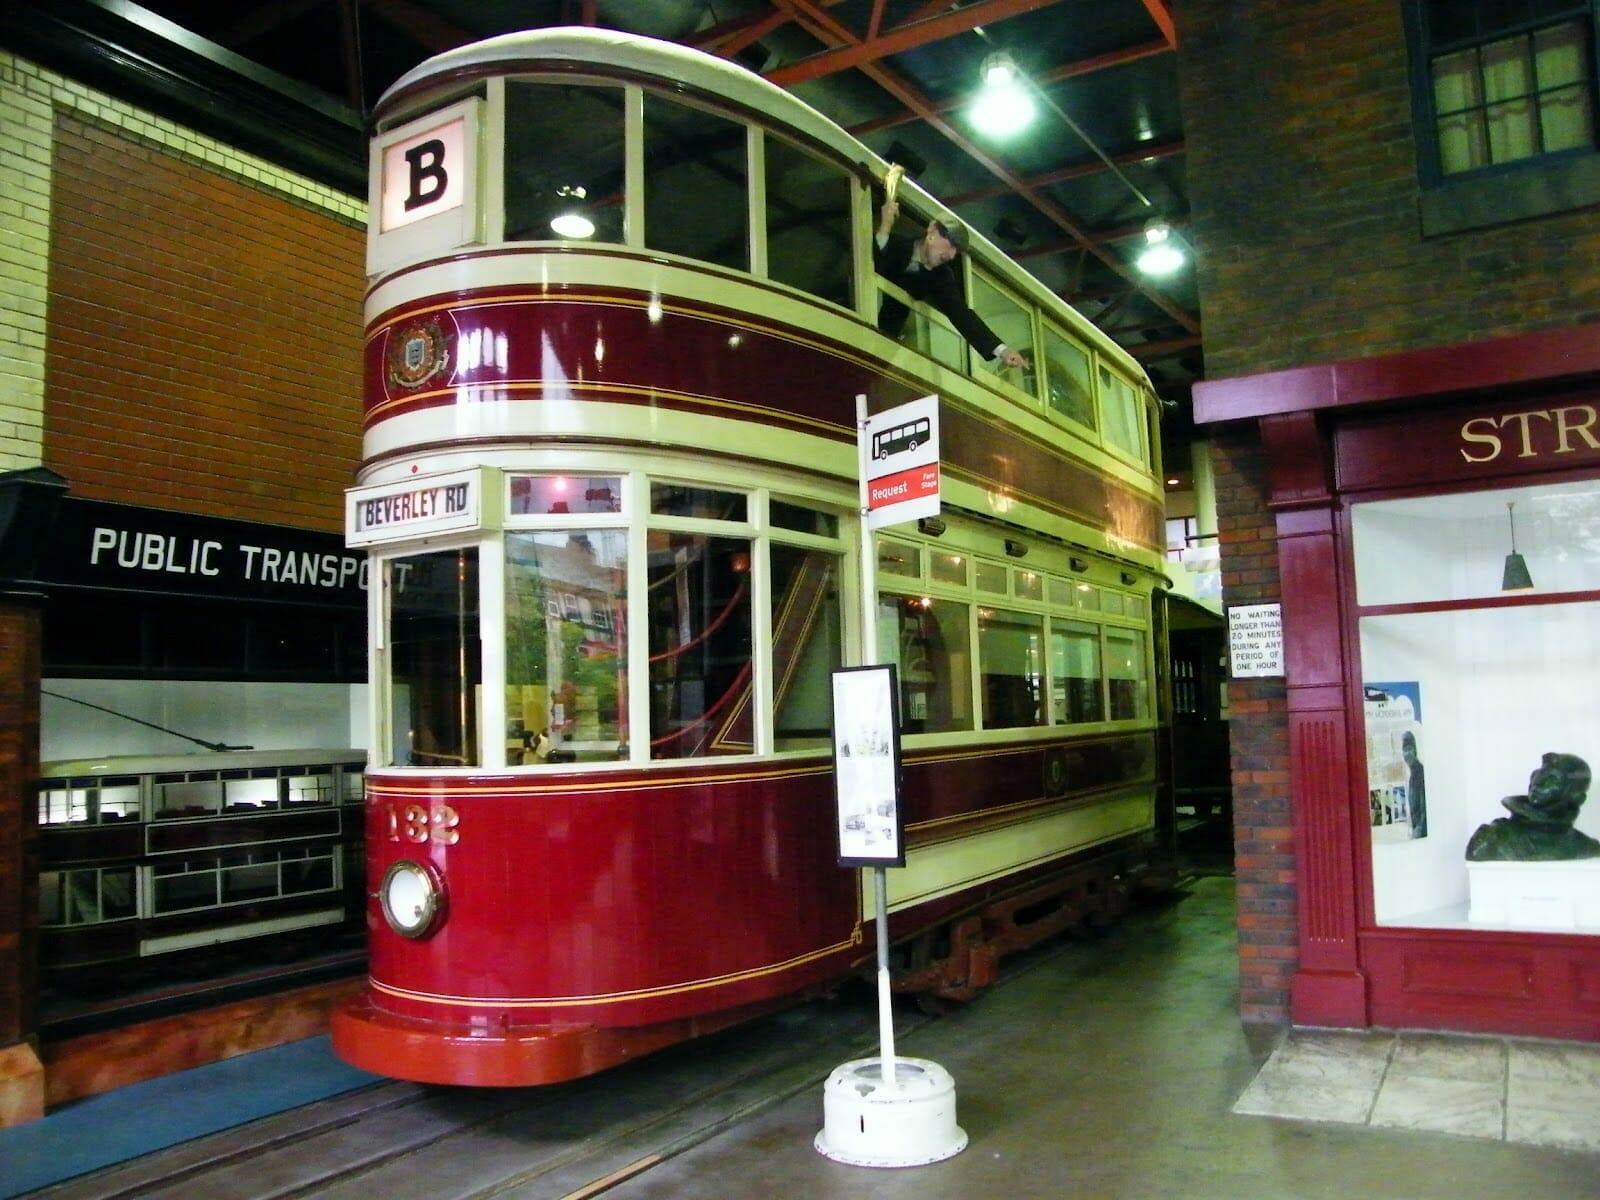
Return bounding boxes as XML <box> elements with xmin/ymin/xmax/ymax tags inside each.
<box><xmin>333</xmin><ymin>29</ymin><xmax>1162</xmax><ymax>1085</ymax></box>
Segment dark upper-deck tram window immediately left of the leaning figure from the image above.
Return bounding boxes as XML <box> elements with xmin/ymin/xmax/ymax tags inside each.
<box><xmin>766</xmin><ymin>138</ymin><xmax>856</xmax><ymax>307</ymax></box>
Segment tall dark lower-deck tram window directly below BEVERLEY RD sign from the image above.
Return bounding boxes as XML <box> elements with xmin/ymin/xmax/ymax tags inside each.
<box><xmin>386</xmin><ymin>547</ymin><xmax>483</xmax><ymax>766</ymax></box>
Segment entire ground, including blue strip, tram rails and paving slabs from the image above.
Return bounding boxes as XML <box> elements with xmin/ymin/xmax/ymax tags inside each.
<box><xmin>0</xmin><ymin>874</ymin><xmax>1600</xmax><ymax>1200</ymax></box>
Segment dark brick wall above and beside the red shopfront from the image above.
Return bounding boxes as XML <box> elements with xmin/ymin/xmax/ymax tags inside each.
<box><xmin>1174</xmin><ymin>0</ymin><xmax>1600</xmax><ymax>1021</ymax></box>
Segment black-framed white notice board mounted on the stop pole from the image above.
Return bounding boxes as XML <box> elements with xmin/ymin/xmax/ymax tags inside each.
<box><xmin>834</xmin><ymin>666</ymin><xmax>906</xmax><ymax>867</ymax></box>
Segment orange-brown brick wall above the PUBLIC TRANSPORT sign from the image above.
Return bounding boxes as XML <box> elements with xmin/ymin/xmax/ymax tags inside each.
<box><xmin>45</xmin><ymin>115</ymin><xmax>365</xmax><ymax>531</ymax></box>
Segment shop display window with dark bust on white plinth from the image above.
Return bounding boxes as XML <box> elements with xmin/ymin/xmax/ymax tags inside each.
<box><xmin>1350</xmin><ymin>483</ymin><xmax>1600</xmax><ymax>933</ymax></box>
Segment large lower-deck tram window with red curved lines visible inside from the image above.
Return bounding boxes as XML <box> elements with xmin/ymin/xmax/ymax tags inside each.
<box><xmin>648</xmin><ymin>531</ymin><xmax>755</xmax><ymax>758</ymax></box>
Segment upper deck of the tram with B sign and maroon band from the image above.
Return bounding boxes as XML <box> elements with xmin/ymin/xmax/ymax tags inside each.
<box><xmin>363</xmin><ymin>29</ymin><xmax>1162</xmax><ymax>571</ymax></box>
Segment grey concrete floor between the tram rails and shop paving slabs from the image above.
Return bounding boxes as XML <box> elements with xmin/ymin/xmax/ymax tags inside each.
<box><xmin>605</xmin><ymin>877</ymin><xmax>1600</xmax><ymax>1200</ymax></box>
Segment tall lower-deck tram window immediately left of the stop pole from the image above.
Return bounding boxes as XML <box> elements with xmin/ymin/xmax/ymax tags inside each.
<box><xmin>770</xmin><ymin>546</ymin><xmax>845</xmax><ymax>750</ymax></box>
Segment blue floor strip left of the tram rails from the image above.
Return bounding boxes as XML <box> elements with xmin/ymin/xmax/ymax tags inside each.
<box><xmin>0</xmin><ymin>1035</ymin><xmax>379</xmax><ymax>1200</ymax></box>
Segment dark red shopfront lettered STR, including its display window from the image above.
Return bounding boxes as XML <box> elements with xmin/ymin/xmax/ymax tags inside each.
<box><xmin>1195</xmin><ymin>325</ymin><xmax>1600</xmax><ymax>1040</ymax></box>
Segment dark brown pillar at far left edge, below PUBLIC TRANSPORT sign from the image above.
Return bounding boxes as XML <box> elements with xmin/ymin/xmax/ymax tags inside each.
<box><xmin>0</xmin><ymin>592</ymin><xmax>45</xmax><ymax>1128</ymax></box>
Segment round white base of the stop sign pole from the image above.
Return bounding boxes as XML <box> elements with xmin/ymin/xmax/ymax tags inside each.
<box><xmin>814</xmin><ymin>1058</ymin><xmax>966</xmax><ymax>1166</ymax></box>
